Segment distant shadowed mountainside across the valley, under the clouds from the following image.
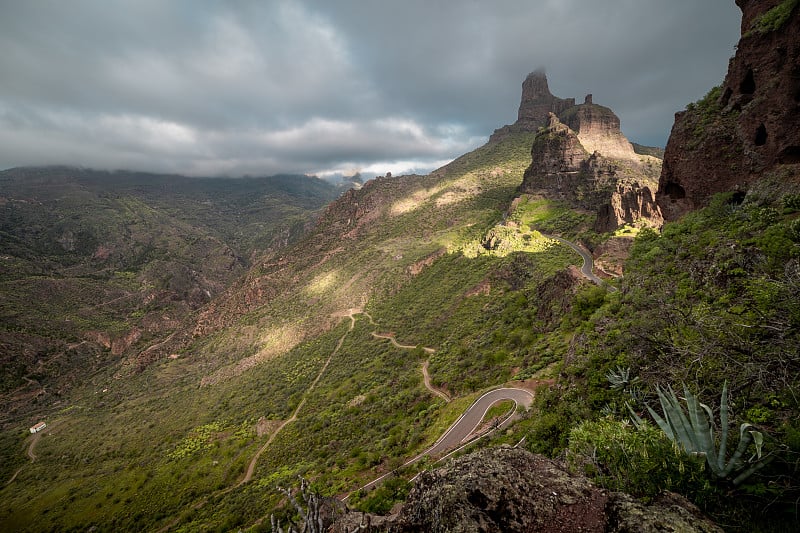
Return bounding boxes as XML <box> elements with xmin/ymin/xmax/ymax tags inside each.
<box><xmin>0</xmin><ymin>167</ymin><xmax>338</xmax><ymax>423</ymax></box>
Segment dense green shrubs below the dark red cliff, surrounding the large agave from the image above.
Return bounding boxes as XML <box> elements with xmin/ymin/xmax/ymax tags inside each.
<box><xmin>526</xmin><ymin>185</ymin><xmax>800</xmax><ymax>530</ymax></box>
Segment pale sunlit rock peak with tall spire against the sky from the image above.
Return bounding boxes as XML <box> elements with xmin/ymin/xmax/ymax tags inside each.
<box><xmin>500</xmin><ymin>70</ymin><xmax>663</xmax><ymax>232</ymax></box>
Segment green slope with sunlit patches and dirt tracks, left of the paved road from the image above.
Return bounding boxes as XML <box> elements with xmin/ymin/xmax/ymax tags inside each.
<box><xmin>0</xmin><ymin>127</ymin><xmax>580</xmax><ymax>530</ymax></box>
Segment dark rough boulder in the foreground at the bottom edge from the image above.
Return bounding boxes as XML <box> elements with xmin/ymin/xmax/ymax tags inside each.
<box><xmin>331</xmin><ymin>446</ymin><xmax>722</xmax><ymax>533</ymax></box>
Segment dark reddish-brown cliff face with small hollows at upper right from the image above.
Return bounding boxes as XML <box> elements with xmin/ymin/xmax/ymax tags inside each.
<box><xmin>657</xmin><ymin>0</ymin><xmax>800</xmax><ymax>219</ymax></box>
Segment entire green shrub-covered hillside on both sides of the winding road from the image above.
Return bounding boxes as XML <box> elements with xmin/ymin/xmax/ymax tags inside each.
<box><xmin>0</xmin><ymin>133</ymin><xmax>800</xmax><ymax>531</ymax></box>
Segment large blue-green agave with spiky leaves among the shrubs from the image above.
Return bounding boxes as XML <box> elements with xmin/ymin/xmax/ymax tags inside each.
<box><xmin>628</xmin><ymin>381</ymin><xmax>771</xmax><ymax>485</ymax></box>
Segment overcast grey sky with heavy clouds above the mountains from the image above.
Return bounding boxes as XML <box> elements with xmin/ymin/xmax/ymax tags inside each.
<box><xmin>0</xmin><ymin>0</ymin><xmax>741</xmax><ymax>177</ymax></box>
